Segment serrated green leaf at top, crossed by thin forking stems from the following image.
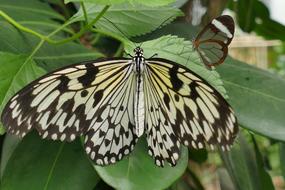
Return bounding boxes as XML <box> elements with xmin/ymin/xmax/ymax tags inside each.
<box><xmin>71</xmin><ymin>3</ymin><xmax>182</xmax><ymax>37</ymax></box>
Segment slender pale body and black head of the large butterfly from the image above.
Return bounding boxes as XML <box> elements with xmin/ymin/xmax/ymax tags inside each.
<box><xmin>133</xmin><ymin>47</ymin><xmax>145</xmax><ymax>136</ymax></box>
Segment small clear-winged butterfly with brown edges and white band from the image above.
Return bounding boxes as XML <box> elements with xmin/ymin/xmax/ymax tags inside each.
<box><xmin>193</xmin><ymin>15</ymin><xmax>235</xmax><ymax>67</ymax></box>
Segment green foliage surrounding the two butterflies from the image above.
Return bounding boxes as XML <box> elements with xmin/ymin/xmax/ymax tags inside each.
<box><xmin>0</xmin><ymin>0</ymin><xmax>285</xmax><ymax>190</ymax></box>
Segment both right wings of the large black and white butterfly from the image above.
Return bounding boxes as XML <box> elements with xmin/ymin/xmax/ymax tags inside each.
<box><xmin>145</xmin><ymin>58</ymin><xmax>238</xmax><ymax>166</ymax></box>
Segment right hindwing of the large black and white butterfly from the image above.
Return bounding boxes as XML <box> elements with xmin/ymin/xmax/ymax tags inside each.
<box><xmin>144</xmin><ymin>67</ymin><xmax>180</xmax><ymax>166</ymax></box>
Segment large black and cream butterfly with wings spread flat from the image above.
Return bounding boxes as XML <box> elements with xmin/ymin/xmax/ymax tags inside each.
<box><xmin>1</xmin><ymin>47</ymin><xmax>238</xmax><ymax>166</ymax></box>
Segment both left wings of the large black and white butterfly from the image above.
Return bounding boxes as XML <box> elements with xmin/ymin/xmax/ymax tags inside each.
<box><xmin>1</xmin><ymin>59</ymin><xmax>137</xmax><ymax>165</ymax></box>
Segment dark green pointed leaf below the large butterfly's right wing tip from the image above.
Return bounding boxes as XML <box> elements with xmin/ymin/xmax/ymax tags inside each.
<box><xmin>221</xmin><ymin>134</ymin><xmax>274</xmax><ymax>190</ymax></box>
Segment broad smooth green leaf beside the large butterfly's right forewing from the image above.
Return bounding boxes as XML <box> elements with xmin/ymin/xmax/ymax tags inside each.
<box><xmin>217</xmin><ymin>58</ymin><xmax>285</xmax><ymax>141</ymax></box>
